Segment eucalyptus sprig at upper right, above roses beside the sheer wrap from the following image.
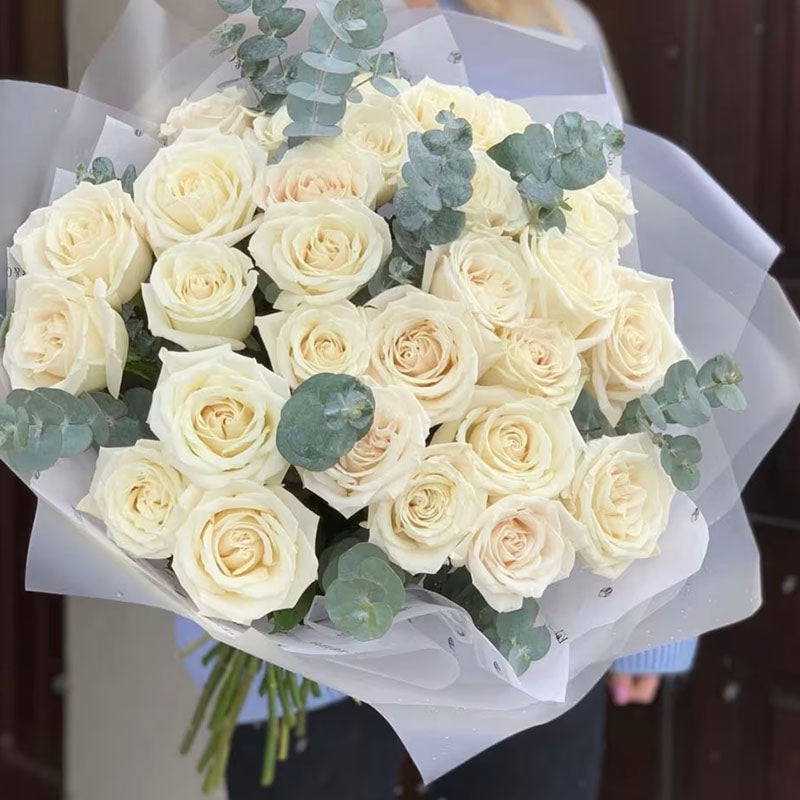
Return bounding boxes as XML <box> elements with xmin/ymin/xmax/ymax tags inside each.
<box><xmin>488</xmin><ymin>111</ymin><xmax>625</xmax><ymax>231</ymax></box>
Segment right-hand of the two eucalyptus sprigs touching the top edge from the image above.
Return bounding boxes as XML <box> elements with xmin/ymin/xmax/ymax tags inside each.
<box><xmin>286</xmin><ymin>0</ymin><xmax>388</xmax><ymax>139</ymax></box>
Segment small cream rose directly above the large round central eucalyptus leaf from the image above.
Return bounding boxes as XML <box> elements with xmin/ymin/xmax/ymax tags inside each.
<box><xmin>256</xmin><ymin>300</ymin><xmax>370</xmax><ymax>389</ymax></box>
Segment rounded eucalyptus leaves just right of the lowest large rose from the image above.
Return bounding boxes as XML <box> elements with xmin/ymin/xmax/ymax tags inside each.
<box><xmin>323</xmin><ymin>540</ymin><xmax>406</xmax><ymax>642</ymax></box>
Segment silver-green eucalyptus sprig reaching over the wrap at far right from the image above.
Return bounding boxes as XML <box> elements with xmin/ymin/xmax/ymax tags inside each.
<box><xmin>572</xmin><ymin>354</ymin><xmax>747</xmax><ymax>492</ymax></box>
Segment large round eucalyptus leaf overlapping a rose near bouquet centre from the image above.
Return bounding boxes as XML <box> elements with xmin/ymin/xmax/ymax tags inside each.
<box><xmin>276</xmin><ymin>373</ymin><xmax>375</xmax><ymax>471</ymax></box>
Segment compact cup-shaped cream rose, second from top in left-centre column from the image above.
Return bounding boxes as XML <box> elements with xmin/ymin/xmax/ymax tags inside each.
<box><xmin>142</xmin><ymin>242</ymin><xmax>258</xmax><ymax>350</ymax></box>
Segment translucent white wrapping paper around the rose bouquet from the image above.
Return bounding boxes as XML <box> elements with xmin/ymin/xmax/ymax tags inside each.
<box><xmin>0</xmin><ymin>0</ymin><xmax>800</xmax><ymax>781</ymax></box>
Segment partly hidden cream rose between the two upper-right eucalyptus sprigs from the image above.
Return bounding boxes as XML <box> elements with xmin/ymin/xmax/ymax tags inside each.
<box><xmin>461</xmin><ymin>150</ymin><xmax>530</xmax><ymax>236</ymax></box>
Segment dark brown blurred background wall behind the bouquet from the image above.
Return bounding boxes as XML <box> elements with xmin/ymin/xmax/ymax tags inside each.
<box><xmin>0</xmin><ymin>0</ymin><xmax>800</xmax><ymax>800</ymax></box>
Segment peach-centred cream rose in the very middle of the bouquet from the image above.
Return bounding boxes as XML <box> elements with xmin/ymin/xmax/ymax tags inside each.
<box><xmin>367</xmin><ymin>286</ymin><xmax>483</xmax><ymax>425</ymax></box>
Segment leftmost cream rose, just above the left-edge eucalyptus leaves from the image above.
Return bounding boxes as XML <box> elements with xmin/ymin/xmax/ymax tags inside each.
<box><xmin>3</xmin><ymin>275</ymin><xmax>128</xmax><ymax>397</ymax></box>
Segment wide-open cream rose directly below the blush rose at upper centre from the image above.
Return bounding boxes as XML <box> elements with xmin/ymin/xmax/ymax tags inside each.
<box><xmin>250</xmin><ymin>198</ymin><xmax>392</xmax><ymax>310</ymax></box>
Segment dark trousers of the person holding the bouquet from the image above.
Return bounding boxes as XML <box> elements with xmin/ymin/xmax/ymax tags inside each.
<box><xmin>228</xmin><ymin>684</ymin><xmax>606</xmax><ymax>800</ymax></box>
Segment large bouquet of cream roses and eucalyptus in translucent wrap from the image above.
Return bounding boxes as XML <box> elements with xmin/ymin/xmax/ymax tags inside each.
<box><xmin>0</xmin><ymin>0</ymin><xmax>800</xmax><ymax>789</ymax></box>
